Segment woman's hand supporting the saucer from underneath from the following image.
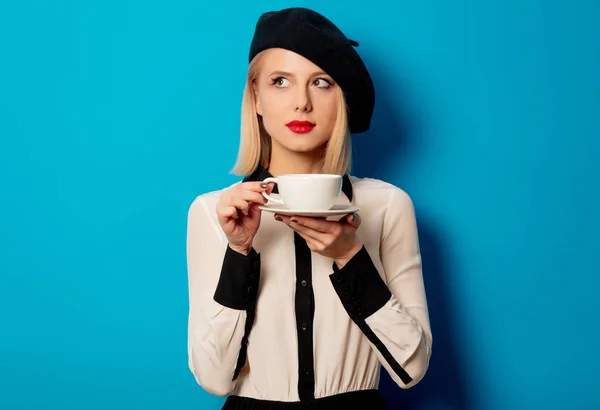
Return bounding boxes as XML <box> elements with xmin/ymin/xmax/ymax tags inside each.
<box><xmin>275</xmin><ymin>213</ymin><xmax>362</xmax><ymax>268</ymax></box>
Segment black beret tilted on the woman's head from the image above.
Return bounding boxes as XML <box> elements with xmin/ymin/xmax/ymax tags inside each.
<box><xmin>249</xmin><ymin>7</ymin><xmax>375</xmax><ymax>134</ymax></box>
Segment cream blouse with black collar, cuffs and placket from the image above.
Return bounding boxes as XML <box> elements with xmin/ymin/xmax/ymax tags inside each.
<box><xmin>187</xmin><ymin>167</ymin><xmax>432</xmax><ymax>402</ymax></box>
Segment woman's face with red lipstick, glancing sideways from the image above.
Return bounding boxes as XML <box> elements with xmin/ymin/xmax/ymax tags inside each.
<box><xmin>254</xmin><ymin>48</ymin><xmax>339</xmax><ymax>152</ymax></box>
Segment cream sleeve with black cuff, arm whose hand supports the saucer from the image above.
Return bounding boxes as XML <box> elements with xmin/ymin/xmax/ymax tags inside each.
<box><xmin>330</xmin><ymin>188</ymin><xmax>432</xmax><ymax>389</ymax></box>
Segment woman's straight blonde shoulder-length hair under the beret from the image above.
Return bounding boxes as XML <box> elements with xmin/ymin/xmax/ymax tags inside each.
<box><xmin>231</xmin><ymin>50</ymin><xmax>352</xmax><ymax>176</ymax></box>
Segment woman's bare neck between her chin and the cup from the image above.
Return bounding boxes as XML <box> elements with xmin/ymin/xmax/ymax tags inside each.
<box><xmin>269</xmin><ymin>144</ymin><xmax>323</xmax><ymax>177</ymax></box>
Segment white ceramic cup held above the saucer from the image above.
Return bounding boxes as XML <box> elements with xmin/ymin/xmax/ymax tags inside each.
<box><xmin>263</xmin><ymin>174</ymin><xmax>342</xmax><ymax>211</ymax></box>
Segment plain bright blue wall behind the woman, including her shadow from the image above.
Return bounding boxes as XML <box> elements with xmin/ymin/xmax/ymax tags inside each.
<box><xmin>0</xmin><ymin>0</ymin><xmax>600</xmax><ymax>410</ymax></box>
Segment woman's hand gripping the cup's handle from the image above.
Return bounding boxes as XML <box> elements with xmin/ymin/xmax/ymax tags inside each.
<box><xmin>217</xmin><ymin>181</ymin><xmax>272</xmax><ymax>255</ymax></box>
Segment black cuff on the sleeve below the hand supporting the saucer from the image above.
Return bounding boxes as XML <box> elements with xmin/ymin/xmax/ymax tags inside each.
<box><xmin>329</xmin><ymin>246</ymin><xmax>392</xmax><ymax>322</ymax></box>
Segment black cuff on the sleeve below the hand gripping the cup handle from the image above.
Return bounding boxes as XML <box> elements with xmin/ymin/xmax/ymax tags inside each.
<box><xmin>214</xmin><ymin>246</ymin><xmax>260</xmax><ymax>310</ymax></box>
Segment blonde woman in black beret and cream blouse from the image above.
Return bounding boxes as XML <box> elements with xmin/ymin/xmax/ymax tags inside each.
<box><xmin>187</xmin><ymin>8</ymin><xmax>432</xmax><ymax>409</ymax></box>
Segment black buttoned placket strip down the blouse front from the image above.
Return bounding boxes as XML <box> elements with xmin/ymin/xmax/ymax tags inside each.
<box><xmin>294</xmin><ymin>232</ymin><xmax>315</xmax><ymax>401</ymax></box>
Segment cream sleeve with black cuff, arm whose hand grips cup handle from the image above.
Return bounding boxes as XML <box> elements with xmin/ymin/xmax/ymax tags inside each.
<box><xmin>186</xmin><ymin>196</ymin><xmax>260</xmax><ymax>396</ymax></box>
